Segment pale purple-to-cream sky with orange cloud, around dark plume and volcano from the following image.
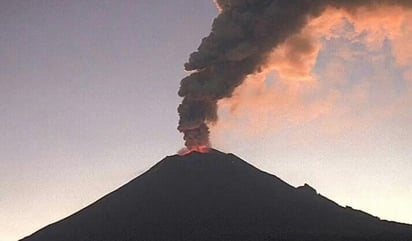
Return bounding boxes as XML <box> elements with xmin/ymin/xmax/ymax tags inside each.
<box><xmin>0</xmin><ymin>0</ymin><xmax>412</xmax><ymax>241</ymax></box>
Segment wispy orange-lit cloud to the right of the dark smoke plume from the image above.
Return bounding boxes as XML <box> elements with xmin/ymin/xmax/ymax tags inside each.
<box><xmin>213</xmin><ymin>6</ymin><xmax>412</xmax><ymax>144</ymax></box>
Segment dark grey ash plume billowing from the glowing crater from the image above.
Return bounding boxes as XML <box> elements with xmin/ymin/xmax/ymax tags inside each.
<box><xmin>178</xmin><ymin>0</ymin><xmax>412</xmax><ymax>150</ymax></box>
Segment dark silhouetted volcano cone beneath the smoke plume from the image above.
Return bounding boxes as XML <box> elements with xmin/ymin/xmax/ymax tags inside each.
<box><xmin>23</xmin><ymin>150</ymin><xmax>412</xmax><ymax>241</ymax></box>
